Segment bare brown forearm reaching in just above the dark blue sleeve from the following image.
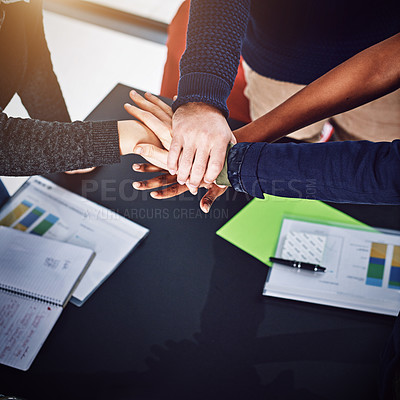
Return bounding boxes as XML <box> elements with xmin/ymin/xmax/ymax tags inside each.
<box><xmin>235</xmin><ymin>34</ymin><xmax>400</xmax><ymax>142</ymax></box>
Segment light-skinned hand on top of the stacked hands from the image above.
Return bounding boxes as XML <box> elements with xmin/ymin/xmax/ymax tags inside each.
<box><xmin>167</xmin><ymin>103</ymin><xmax>235</xmax><ymax>193</ymax></box>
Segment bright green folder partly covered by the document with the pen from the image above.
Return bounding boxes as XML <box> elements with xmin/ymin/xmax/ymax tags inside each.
<box><xmin>217</xmin><ymin>195</ymin><xmax>373</xmax><ymax>264</ymax></box>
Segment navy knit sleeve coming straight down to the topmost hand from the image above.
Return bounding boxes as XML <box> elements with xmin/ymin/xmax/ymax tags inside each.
<box><xmin>172</xmin><ymin>0</ymin><xmax>250</xmax><ymax>117</ymax></box>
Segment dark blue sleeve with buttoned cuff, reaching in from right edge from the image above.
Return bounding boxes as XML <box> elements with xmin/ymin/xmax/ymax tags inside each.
<box><xmin>228</xmin><ymin>140</ymin><xmax>400</xmax><ymax>204</ymax></box>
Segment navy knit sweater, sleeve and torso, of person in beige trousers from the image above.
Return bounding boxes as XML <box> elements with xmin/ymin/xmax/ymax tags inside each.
<box><xmin>173</xmin><ymin>0</ymin><xmax>400</xmax><ymax>116</ymax></box>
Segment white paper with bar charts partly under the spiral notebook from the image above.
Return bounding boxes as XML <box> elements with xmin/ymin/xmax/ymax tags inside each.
<box><xmin>0</xmin><ymin>176</ymin><xmax>149</xmax><ymax>305</ymax></box>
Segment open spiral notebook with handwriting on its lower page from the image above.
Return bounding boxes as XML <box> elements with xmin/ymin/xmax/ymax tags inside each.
<box><xmin>0</xmin><ymin>227</ymin><xmax>94</xmax><ymax>371</ymax></box>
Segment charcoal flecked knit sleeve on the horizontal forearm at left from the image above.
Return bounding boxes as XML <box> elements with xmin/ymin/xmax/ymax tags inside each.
<box><xmin>0</xmin><ymin>113</ymin><xmax>120</xmax><ymax>175</ymax></box>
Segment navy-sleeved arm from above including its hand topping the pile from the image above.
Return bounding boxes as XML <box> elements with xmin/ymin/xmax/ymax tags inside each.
<box><xmin>168</xmin><ymin>0</ymin><xmax>250</xmax><ymax>193</ymax></box>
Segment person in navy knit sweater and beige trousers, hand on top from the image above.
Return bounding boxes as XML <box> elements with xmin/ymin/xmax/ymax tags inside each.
<box><xmin>167</xmin><ymin>0</ymin><xmax>400</xmax><ymax>193</ymax></box>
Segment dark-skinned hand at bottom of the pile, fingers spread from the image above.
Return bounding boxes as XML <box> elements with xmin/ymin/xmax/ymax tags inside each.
<box><xmin>132</xmin><ymin>164</ymin><xmax>227</xmax><ymax>213</ymax></box>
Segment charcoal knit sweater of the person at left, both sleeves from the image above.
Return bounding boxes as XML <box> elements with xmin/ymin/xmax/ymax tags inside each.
<box><xmin>0</xmin><ymin>0</ymin><xmax>120</xmax><ymax>175</ymax></box>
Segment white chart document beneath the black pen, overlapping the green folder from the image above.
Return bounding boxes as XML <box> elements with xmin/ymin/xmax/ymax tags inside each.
<box><xmin>263</xmin><ymin>219</ymin><xmax>400</xmax><ymax>315</ymax></box>
